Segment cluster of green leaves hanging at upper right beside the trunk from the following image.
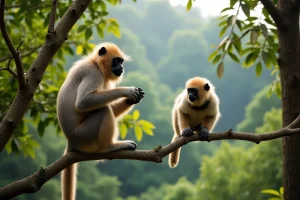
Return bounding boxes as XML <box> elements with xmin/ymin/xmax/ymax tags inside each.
<box><xmin>208</xmin><ymin>0</ymin><xmax>280</xmax><ymax>89</ymax></box>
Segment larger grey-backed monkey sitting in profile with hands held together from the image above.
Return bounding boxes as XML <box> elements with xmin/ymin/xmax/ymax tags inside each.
<box><xmin>57</xmin><ymin>43</ymin><xmax>145</xmax><ymax>200</ymax></box>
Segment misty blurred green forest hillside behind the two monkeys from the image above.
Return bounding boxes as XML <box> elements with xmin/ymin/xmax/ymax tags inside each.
<box><xmin>0</xmin><ymin>1</ymin><xmax>282</xmax><ymax>200</ymax></box>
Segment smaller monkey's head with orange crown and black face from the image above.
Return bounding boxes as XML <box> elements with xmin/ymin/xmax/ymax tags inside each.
<box><xmin>186</xmin><ymin>77</ymin><xmax>210</xmax><ymax>106</ymax></box>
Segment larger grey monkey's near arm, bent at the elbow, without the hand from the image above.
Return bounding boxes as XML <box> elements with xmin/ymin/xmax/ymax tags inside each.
<box><xmin>75</xmin><ymin>75</ymin><xmax>130</xmax><ymax>112</ymax></box>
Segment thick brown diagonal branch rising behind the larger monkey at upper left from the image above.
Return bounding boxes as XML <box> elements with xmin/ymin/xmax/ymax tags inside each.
<box><xmin>0</xmin><ymin>0</ymin><xmax>92</xmax><ymax>152</ymax></box>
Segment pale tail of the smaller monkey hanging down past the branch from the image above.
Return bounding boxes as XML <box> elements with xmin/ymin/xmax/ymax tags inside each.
<box><xmin>169</xmin><ymin>110</ymin><xmax>181</xmax><ymax>168</ymax></box>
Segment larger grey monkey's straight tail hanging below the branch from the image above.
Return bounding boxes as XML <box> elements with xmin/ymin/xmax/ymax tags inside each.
<box><xmin>61</xmin><ymin>148</ymin><xmax>78</xmax><ymax>200</ymax></box>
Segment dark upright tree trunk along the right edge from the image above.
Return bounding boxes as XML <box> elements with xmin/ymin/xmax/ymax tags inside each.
<box><xmin>278</xmin><ymin>0</ymin><xmax>300</xmax><ymax>200</ymax></box>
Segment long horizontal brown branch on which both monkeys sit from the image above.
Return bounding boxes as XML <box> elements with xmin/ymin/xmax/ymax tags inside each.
<box><xmin>0</xmin><ymin>116</ymin><xmax>300</xmax><ymax>199</ymax></box>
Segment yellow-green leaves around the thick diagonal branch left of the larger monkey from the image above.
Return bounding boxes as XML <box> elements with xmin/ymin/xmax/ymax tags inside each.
<box><xmin>0</xmin><ymin>0</ymin><xmax>154</xmax><ymax>158</ymax></box>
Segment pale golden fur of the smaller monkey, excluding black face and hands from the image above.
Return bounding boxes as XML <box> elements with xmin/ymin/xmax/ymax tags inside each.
<box><xmin>169</xmin><ymin>77</ymin><xmax>221</xmax><ymax>168</ymax></box>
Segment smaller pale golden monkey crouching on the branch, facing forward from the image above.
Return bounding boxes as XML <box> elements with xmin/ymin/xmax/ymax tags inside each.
<box><xmin>169</xmin><ymin>77</ymin><xmax>221</xmax><ymax>168</ymax></box>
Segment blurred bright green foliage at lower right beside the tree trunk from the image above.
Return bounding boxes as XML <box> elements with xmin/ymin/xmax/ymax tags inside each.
<box><xmin>195</xmin><ymin>109</ymin><xmax>282</xmax><ymax>200</ymax></box>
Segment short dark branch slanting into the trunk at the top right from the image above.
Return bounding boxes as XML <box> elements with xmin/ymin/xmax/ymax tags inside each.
<box><xmin>260</xmin><ymin>0</ymin><xmax>291</xmax><ymax>30</ymax></box>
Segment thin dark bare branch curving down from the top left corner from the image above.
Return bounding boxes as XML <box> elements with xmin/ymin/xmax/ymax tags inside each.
<box><xmin>0</xmin><ymin>0</ymin><xmax>26</xmax><ymax>90</ymax></box>
